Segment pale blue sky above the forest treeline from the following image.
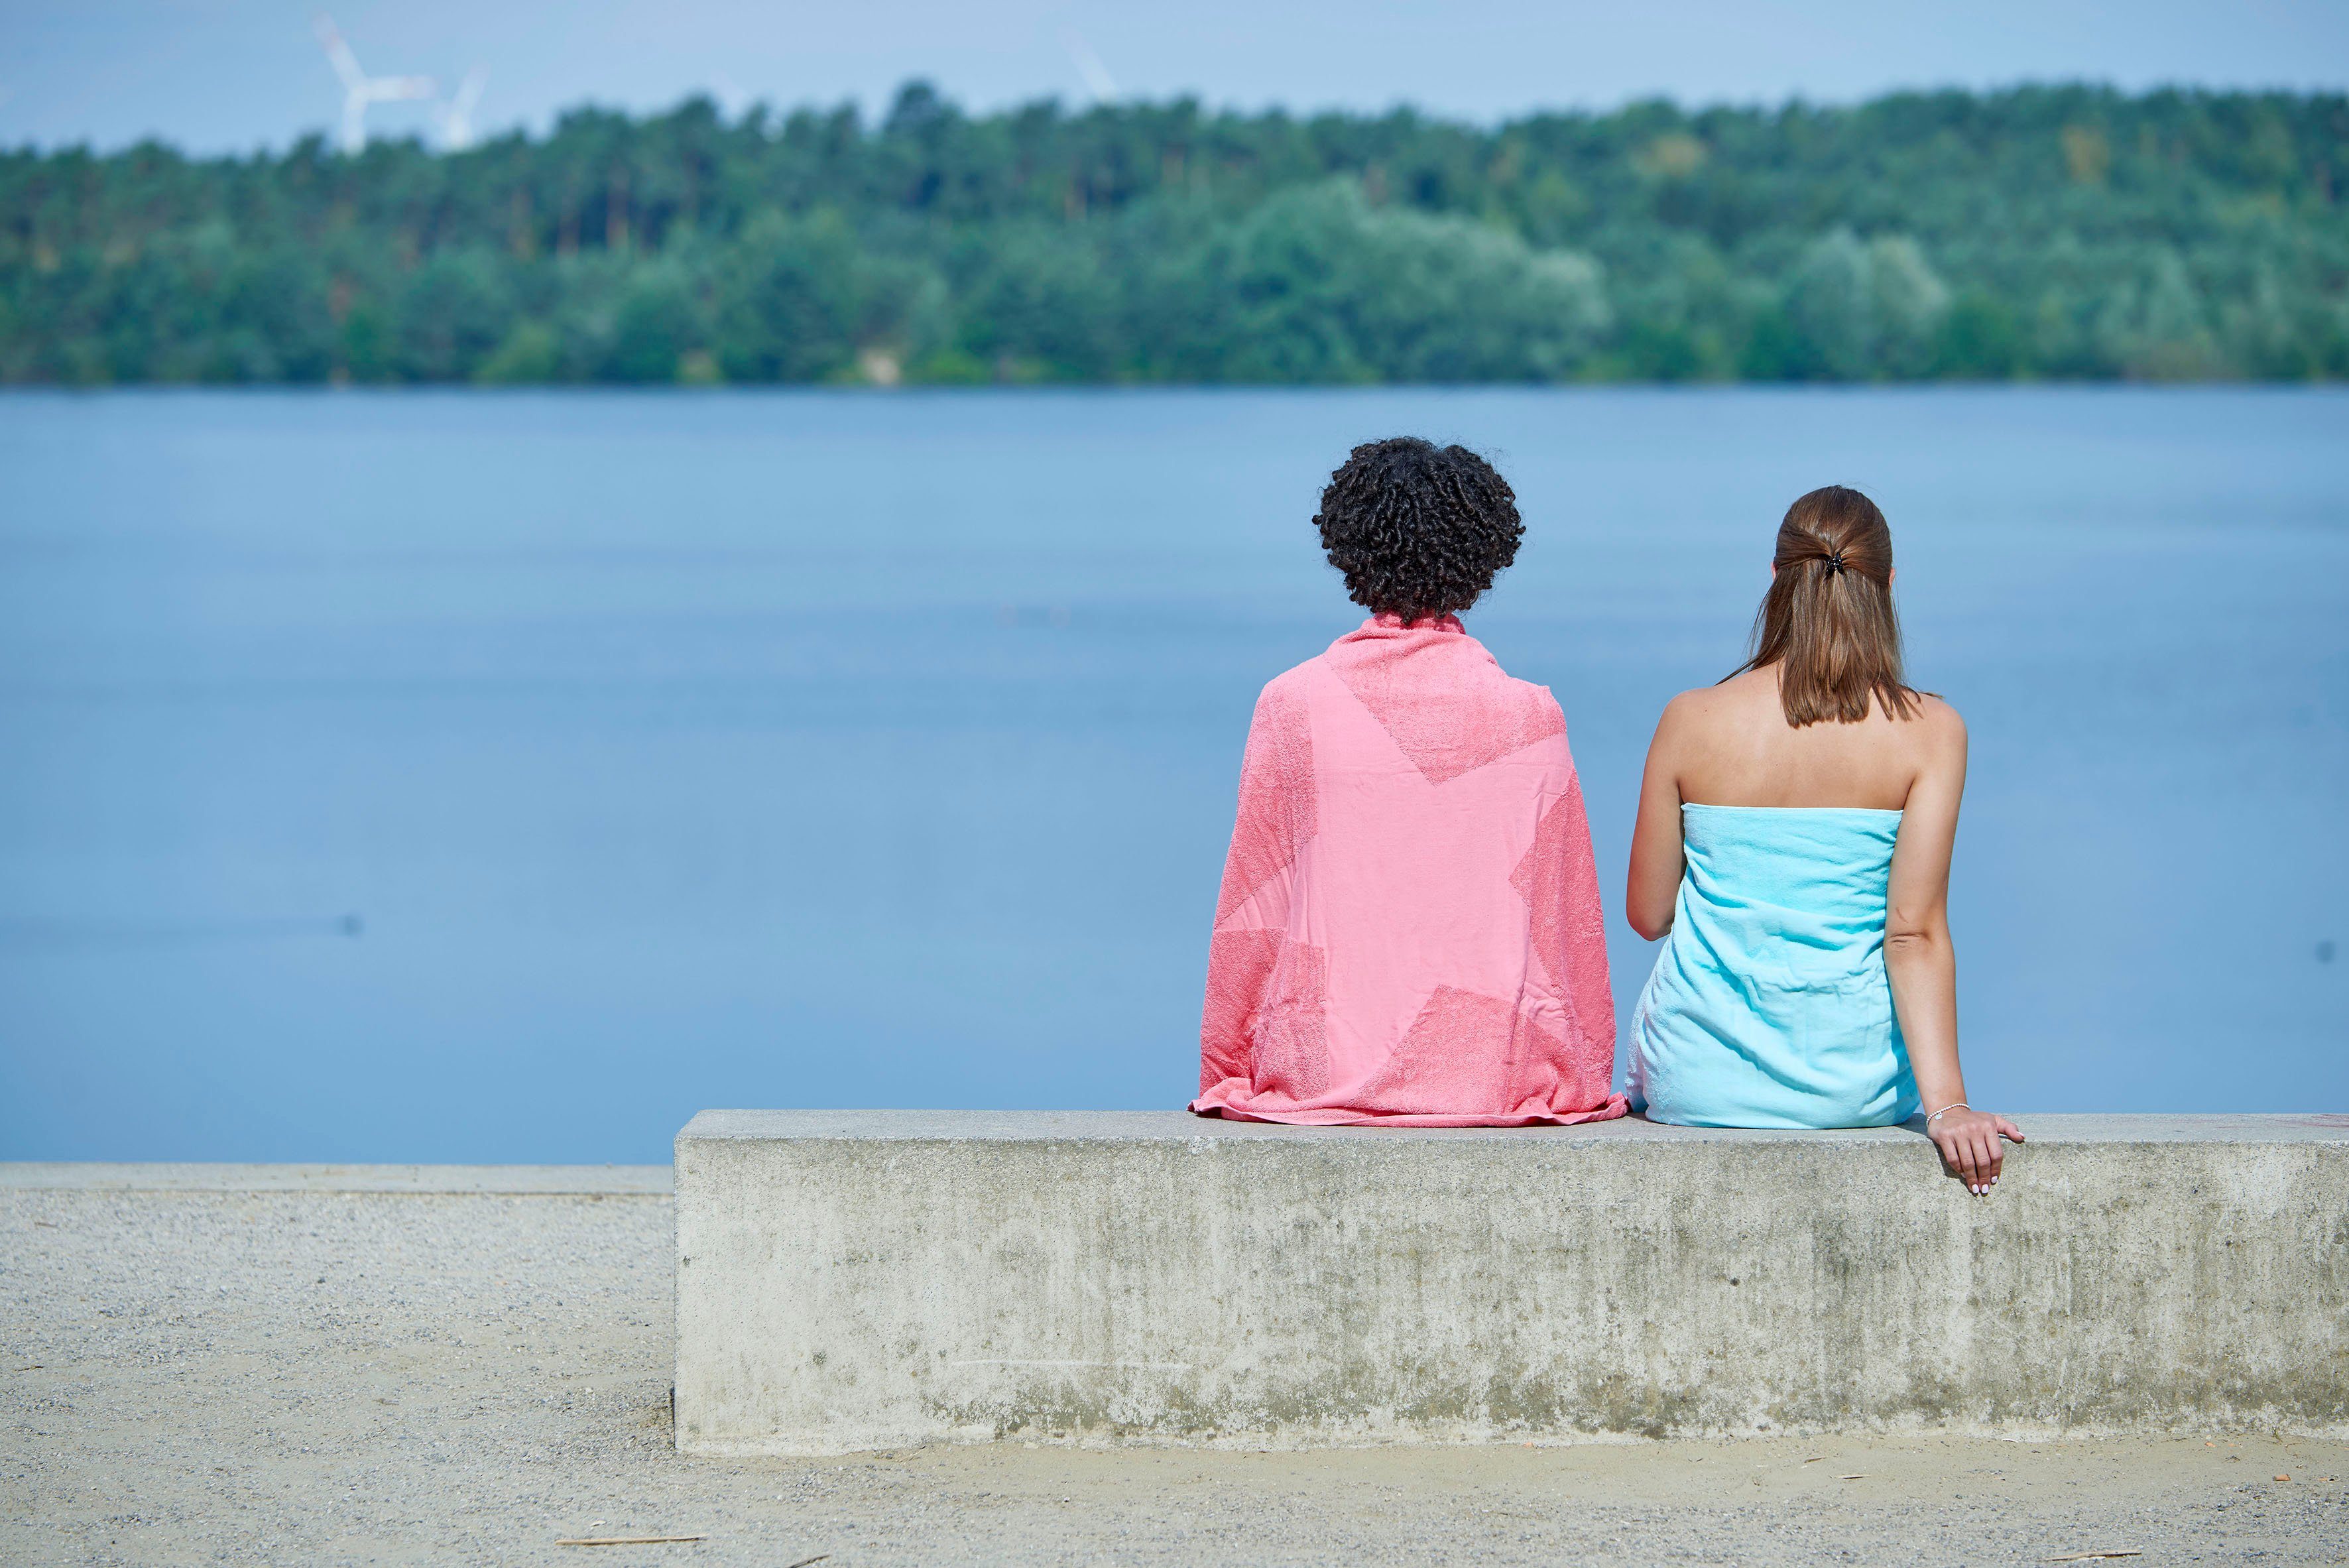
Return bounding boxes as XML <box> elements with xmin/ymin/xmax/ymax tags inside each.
<box><xmin>0</xmin><ymin>0</ymin><xmax>2349</xmax><ymax>151</ymax></box>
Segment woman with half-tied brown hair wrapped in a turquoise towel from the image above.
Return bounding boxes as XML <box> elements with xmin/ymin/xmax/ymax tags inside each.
<box><xmin>1626</xmin><ymin>486</ymin><xmax>2023</xmax><ymax>1195</ymax></box>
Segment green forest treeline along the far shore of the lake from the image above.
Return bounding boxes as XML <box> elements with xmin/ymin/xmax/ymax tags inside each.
<box><xmin>0</xmin><ymin>82</ymin><xmax>2349</xmax><ymax>385</ymax></box>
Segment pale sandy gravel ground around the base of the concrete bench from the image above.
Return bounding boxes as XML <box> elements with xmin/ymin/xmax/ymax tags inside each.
<box><xmin>0</xmin><ymin>1185</ymin><xmax>2349</xmax><ymax>1568</ymax></box>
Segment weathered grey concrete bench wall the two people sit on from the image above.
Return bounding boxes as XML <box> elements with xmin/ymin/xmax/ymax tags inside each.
<box><xmin>676</xmin><ymin>1113</ymin><xmax>2349</xmax><ymax>1455</ymax></box>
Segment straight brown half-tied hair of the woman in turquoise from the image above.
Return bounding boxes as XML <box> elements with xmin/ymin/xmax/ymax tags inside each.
<box><xmin>1729</xmin><ymin>483</ymin><xmax>1917</xmax><ymax>730</ymax></box>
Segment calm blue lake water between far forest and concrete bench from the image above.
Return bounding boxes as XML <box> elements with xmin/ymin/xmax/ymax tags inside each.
<box><xmin>0</xmin><ymin>390</ymin><xmax>2349</xmax><ymax>1162</ymax></box>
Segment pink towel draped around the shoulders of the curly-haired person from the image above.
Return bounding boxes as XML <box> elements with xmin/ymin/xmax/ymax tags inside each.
<box><xmin>1191</xmin><ymin>615</ymin><xmax>1623</xmax><ymax>1126</ymax></box>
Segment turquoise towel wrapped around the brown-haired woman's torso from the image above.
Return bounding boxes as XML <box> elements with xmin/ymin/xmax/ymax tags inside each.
<box><xmin>1630</xmin><ymin>805</ymin><xmax>1919</xmax><ymax>1126</ymax></box>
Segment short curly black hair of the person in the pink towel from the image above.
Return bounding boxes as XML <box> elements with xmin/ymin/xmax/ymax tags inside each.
<box><xmin>1313</xmin><ymin>437</ymin><xmax>1524</xmax><ymax>622</ymax></box>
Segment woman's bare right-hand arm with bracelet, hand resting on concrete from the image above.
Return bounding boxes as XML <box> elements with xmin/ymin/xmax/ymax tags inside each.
<box><xmin>1884</xmin><ymin>697</ymin><xmax>2023</xmax><ymax>1195</ymax></box>
